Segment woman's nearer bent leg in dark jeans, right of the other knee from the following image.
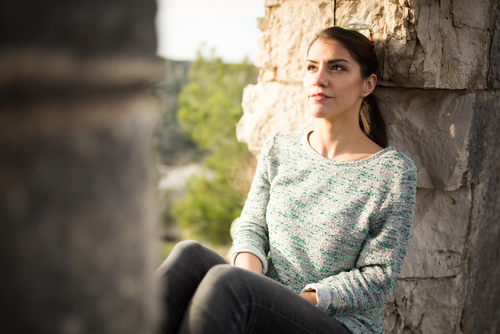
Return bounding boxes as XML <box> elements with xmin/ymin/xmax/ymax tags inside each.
<box><xmin>179</xmin><ymin>265</ymin><xmax>350</xmax><ymax>334</ymax></box>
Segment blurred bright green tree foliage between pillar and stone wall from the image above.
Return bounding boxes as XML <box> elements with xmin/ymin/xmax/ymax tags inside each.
<box><xmin>173</xmin><ymin>53</ymin><xmax>257</xmax><ymax>244</ymax></box>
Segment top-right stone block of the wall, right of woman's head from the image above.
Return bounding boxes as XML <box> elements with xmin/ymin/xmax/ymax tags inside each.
<box><xmin>336</xmin><ymin>0</ymin><xmax>494</xmax><ymax>89</ymax></box>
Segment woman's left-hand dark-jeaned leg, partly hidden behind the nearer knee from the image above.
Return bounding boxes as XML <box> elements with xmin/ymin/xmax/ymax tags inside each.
<box><xmin>156</xmin><ymin>241</ymin><xmax>229</xmax><ymax>334</ymax></box>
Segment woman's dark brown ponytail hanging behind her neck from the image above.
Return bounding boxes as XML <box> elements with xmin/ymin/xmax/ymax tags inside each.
<box><xmin>359</xmin><ymin>94</ymin><xmax>389</xmax><ymax>148</ymax></box>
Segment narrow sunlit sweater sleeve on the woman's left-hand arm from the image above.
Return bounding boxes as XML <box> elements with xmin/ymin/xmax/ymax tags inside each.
<box><xmin>231</xmin><ymin>135</ymin><xmax>276</xmax><ymax>274</ymax></box>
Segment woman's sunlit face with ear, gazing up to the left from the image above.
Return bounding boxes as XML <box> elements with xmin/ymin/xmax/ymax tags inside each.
<box><xmin>304</xmin><ymin>39</ymin><xmax>376</xmax><ymax>121</ymax></box>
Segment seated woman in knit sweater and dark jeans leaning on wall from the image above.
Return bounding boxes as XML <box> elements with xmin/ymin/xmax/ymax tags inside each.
<box><xmin>158</xmin><ymin>27</ymin><xmax>416</xmax><ymax>334</ymax></box>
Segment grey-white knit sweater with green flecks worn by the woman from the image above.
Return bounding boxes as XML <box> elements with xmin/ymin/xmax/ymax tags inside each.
<box><xmin>232</xmin><ymin>132</ymin><xmax>417</xmax><ymax>333</ymax></box>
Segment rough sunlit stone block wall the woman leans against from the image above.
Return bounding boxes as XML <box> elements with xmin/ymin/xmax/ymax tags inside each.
<box><xmin>237</xmin><ymin>0</ymin><xmax>500</xmax><ymax>334</ymax></box>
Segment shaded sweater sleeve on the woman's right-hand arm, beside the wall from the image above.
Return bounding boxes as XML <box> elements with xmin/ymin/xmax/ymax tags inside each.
<box><xmin>302</xmin><ymin>169</ymin><xmax>417</xmax><ymax>315</ymax></box>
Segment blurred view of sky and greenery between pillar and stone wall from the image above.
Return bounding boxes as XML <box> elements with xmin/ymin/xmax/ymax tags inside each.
<box><xmin>152</xmin><ymin>0</ymin><xmax>265</xmax><ymax>260</ymax></box>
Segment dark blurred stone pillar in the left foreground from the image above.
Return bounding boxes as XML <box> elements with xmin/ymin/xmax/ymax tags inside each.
<box><xmin>0</xmin><ymin>0</ymin><xmax>158</xmax><ymax>334</ymax></box>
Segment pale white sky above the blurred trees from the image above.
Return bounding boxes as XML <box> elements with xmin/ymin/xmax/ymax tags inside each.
<box><xmin>156</xmin><ymin>0</ymin><xmax>265</xmax><ymax>63</ymax></box>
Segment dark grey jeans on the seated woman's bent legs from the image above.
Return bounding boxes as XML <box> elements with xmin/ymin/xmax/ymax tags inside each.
<box><xmin>157</xmin><ymin>241</ymin><xmax>352</xmax><ymax>334</ymax></box>
